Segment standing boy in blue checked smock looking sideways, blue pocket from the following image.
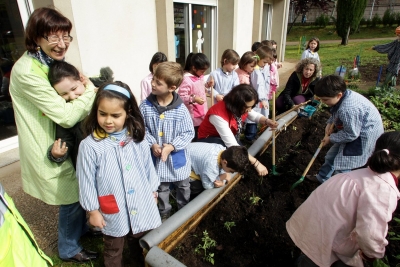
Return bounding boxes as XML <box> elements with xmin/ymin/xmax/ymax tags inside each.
<box><xmin>140</xmin><ymin>62</ymin><xmax>194</xmax><ymax>221</ymax></box>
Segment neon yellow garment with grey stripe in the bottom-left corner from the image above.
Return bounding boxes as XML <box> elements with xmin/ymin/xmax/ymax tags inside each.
<box><xmin>0</xmin><ymin>184</ymin><xmax>53</xmax><ymax>267</ymax></box>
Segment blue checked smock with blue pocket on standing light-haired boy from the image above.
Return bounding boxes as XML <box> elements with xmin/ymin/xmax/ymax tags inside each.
<box><xmin>140</xmin><ymin>99</ymin><xmax>194</xmax><ymax>182</ymax></box>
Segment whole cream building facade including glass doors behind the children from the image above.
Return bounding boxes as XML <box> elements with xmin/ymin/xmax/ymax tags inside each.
<box><xmin>0</xmin><ymin>0</ymin><xmax>290</xmax><ymax>142</ymax></box>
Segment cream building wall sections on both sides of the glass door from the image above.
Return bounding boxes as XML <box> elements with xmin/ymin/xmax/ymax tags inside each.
<box><xmin>26</xmin><ymin>0</ymin><xmax>289</xmax><ymax>97</ymax></box>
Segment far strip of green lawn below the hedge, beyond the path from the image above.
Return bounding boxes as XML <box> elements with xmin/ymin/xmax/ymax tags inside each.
<box><xmin>286</xmin><ymin>24</ymin><xmax>396</xmax><ymax>42</ymax></box>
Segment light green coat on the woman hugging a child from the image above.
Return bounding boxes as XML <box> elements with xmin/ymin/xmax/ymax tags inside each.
<box><xmin>10</xmin><ymin>53</ymin><xmax>95</xmax><ymax>205</ymax></box>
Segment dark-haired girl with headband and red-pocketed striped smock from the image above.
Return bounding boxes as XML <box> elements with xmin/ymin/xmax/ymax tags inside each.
<box><xmin>76</xmin><ymin>82</ymin><xmax>161</xmax><ymax>267</ymax></box>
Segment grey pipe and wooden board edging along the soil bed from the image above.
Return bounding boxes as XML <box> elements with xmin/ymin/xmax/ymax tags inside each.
<box><xmin>139</xmin><ymin>111</ymin><xmax>298</xmax><ymax>267</ymax></box>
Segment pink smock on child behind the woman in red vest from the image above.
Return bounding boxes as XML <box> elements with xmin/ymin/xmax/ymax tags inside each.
<box><xmin>178</xmin><ymin>72</ymin><xmax>208</xmax><ymax>126</ymax></box>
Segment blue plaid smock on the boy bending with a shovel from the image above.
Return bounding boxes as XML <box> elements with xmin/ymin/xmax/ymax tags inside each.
<box><xmin>328</xmin><ymin>90</ymin><xmax>383</xmax><ymax>170</ymax></box>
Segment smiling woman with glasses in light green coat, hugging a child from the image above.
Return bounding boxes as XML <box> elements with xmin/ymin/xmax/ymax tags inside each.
<box><xmin>10</xmin><ymin>8</ymin><xmax>97</xmax><ymax>262</ymax></box>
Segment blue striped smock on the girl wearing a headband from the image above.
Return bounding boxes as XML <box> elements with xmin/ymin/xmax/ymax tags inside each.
<box><xmin>76</xmin><ymin>136</ymin><xmax>161</xmax><ymax>237</ymax></box>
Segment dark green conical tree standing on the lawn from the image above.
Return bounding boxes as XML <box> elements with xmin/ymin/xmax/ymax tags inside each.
<box><xmin>336</xmin><ymin>0</ymin><xmax>367</xmax><ymax>45</ymax></box>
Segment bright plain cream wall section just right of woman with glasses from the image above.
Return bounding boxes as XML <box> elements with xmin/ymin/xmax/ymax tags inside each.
<box><xmin>63</xmin><ymin>0</ymin><xmax>158</xmax><ymax>99</ymax></box>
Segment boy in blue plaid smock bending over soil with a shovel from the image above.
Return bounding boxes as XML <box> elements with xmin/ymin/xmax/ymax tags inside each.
<box><xmin>306</xmin><ymin>75</ymin><xmax>383</xmax><ymax>183</ymax></box>
